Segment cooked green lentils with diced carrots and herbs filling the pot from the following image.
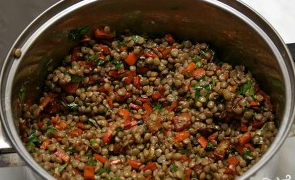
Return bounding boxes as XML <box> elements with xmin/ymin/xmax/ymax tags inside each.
<box><xmin>20</xmin><ymin>26</ymin><xmax>277</xmax><ymax>180</ymax></box>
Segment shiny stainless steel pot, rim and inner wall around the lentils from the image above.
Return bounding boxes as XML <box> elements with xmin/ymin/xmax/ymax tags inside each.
<box><xmin>0</xmin><ymin>0</ymin><xmax>295</xmax><ymax>179</ymax></box>
